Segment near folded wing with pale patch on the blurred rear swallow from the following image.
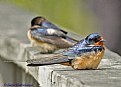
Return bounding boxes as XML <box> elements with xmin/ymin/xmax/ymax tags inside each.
<box><xmin>31</xmin><ymin>27</ymin><xmax>74</xmax><ymax>48</ymax></box>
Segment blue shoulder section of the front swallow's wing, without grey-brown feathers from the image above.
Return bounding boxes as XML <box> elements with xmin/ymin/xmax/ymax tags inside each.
<box><xmin>63</xmin><ymin>46</ymin><xmax>104</xmax><ymax>59</ymax></box>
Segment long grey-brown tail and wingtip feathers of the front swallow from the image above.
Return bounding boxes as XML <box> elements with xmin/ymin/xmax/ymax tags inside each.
<box><xmin>26</xmin><ymin>54</ymin><xmax>70</xmax><ymax>66</ymax></box>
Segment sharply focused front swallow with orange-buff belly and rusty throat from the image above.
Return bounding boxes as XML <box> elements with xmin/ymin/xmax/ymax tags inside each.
<box><xmin>27</xmin><ymin>33</ymin><xmax>105</xmax><ymax>70</ymax></box>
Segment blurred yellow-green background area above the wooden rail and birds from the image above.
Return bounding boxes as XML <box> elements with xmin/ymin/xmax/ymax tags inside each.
<box><xmin>3</xmin><ymin>0</ymin><xmax>98</xmax><ymax>35</ymax></box>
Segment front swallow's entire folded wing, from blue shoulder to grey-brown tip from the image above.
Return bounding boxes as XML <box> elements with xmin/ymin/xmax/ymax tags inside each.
<box><xmin>27</xmin><ymin>46</ymin><xmax>104</xmax><ymax>66</ymax></box>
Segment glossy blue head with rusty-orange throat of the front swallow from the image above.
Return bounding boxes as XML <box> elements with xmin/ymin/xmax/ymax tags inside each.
<box><xmin>85</xmin><ymin>33</ymin><xmax>105</xmax><ymax>46</ymax></box>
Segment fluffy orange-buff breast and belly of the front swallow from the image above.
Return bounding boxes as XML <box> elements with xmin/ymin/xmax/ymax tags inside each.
<box><xmin>72</xmin><ymin>50</ymin><xmax>104</xmax><ymax>69</ymax></box>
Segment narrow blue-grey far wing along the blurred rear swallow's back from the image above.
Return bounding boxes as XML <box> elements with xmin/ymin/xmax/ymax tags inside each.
<box><xmin>42</xmin><ymin>20</ymin><xmax>68</xmax><ymax>34</ymax></box>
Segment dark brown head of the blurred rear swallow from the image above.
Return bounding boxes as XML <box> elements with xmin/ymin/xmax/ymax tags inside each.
<box><xmin>31</xmin><ymin>16</ymin><xmax>46</xmax><ymax>26</ymax></box>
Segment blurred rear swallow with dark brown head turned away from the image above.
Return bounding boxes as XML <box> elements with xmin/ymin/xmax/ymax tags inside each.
<box><xmin>27</xmin><ymin>16</ymin><xmax>78</xmax><ymax>53</ymax></box>
